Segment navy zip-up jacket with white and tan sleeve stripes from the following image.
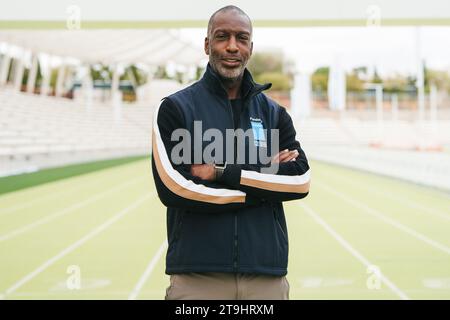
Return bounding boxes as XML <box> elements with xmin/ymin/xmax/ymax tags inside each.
<box><xmin>152</xmin><ymin>65</ymin><xmax>310</xmax><ymax>276</ymax></box>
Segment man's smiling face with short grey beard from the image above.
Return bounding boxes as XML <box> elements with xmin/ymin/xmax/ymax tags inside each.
<box><xmin>205</xmin><ymin>10</ymin><xmax>253</xmax><ymax>80</ymax></box>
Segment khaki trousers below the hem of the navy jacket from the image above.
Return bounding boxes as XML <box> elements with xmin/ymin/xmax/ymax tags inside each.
<box><xmin>165</xmin><ymin>272</ymin><xmax>289</xmax><ymax>300</ymax></box>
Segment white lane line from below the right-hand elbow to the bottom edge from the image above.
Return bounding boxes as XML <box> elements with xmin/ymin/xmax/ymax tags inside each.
<box><xmin>299</xmin><ymin>203</ymin><xmax>409</xmax><ymax>300</ymax></box>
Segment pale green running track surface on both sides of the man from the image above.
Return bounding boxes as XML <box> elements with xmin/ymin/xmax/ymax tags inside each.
<box><xmin>0</xmin><ymin>159</ymin><xmax>450</xmax><ymax>299</ymax></box>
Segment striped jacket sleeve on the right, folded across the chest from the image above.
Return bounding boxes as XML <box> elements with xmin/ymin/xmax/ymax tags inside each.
<box><xmin>220</xmin><ymin>107</ymin><xmax>310</xmax><ymax>202</ymax></box>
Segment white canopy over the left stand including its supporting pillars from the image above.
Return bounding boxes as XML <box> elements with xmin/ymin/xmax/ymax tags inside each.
<box><xmin>0</xmin><ymin>29</ymin><xmax>205</xmax><ymax>102</ymax></box>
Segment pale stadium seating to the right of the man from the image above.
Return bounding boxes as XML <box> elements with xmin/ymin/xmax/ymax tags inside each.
<box><xmin>294</xmin><ymin>111</ymin><xmax>450</xmax><ymax>191</ymax></box>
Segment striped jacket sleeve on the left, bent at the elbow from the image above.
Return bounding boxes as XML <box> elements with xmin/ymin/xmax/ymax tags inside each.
<box><xmin>152</xmin><ymin>98</ymin><xmax>260</xmax><ymax>212</ymax></box>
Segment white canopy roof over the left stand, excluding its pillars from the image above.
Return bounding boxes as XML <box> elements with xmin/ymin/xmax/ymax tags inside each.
<box><xmin>0</xmin><ymin>29</ymin><xmax>204</xmax><ymax>65</ymax></box>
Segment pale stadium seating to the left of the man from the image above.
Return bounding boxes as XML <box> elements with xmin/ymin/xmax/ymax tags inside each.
<box><xmin>0</xmin><ymin>88</ymin><xmax>154</xmax><ymax>176</ymax></box>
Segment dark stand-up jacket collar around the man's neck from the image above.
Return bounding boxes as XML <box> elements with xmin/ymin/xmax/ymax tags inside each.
<box><xmin>200</xmin><ymin>63</ymin><xmax>272</xmax><ymax>101</ymax></box>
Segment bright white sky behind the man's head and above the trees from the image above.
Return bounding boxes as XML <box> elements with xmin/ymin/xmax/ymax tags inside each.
<box><xmin>180</xmin><ymin>26</ymin><xmax>450</xmax><ymax>75</ymax></box>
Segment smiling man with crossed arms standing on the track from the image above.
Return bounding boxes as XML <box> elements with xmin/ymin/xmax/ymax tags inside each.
<box><xmin>152</xmin><ymin>6</ymin><xmax>309</xmax><ymax>299</ymax></box>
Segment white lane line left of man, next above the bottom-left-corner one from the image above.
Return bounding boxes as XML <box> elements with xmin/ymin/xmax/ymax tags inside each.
<box><xmin>0</xmin><ymin>177</ymin><xmax>146</xmax><ymax>242</ymax></box>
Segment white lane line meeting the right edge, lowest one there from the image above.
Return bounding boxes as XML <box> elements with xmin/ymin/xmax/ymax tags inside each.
<box><xmin>315</xmin><ymin>182</ymin><xmax>450</xmax><ymax>254</ymax></box>
